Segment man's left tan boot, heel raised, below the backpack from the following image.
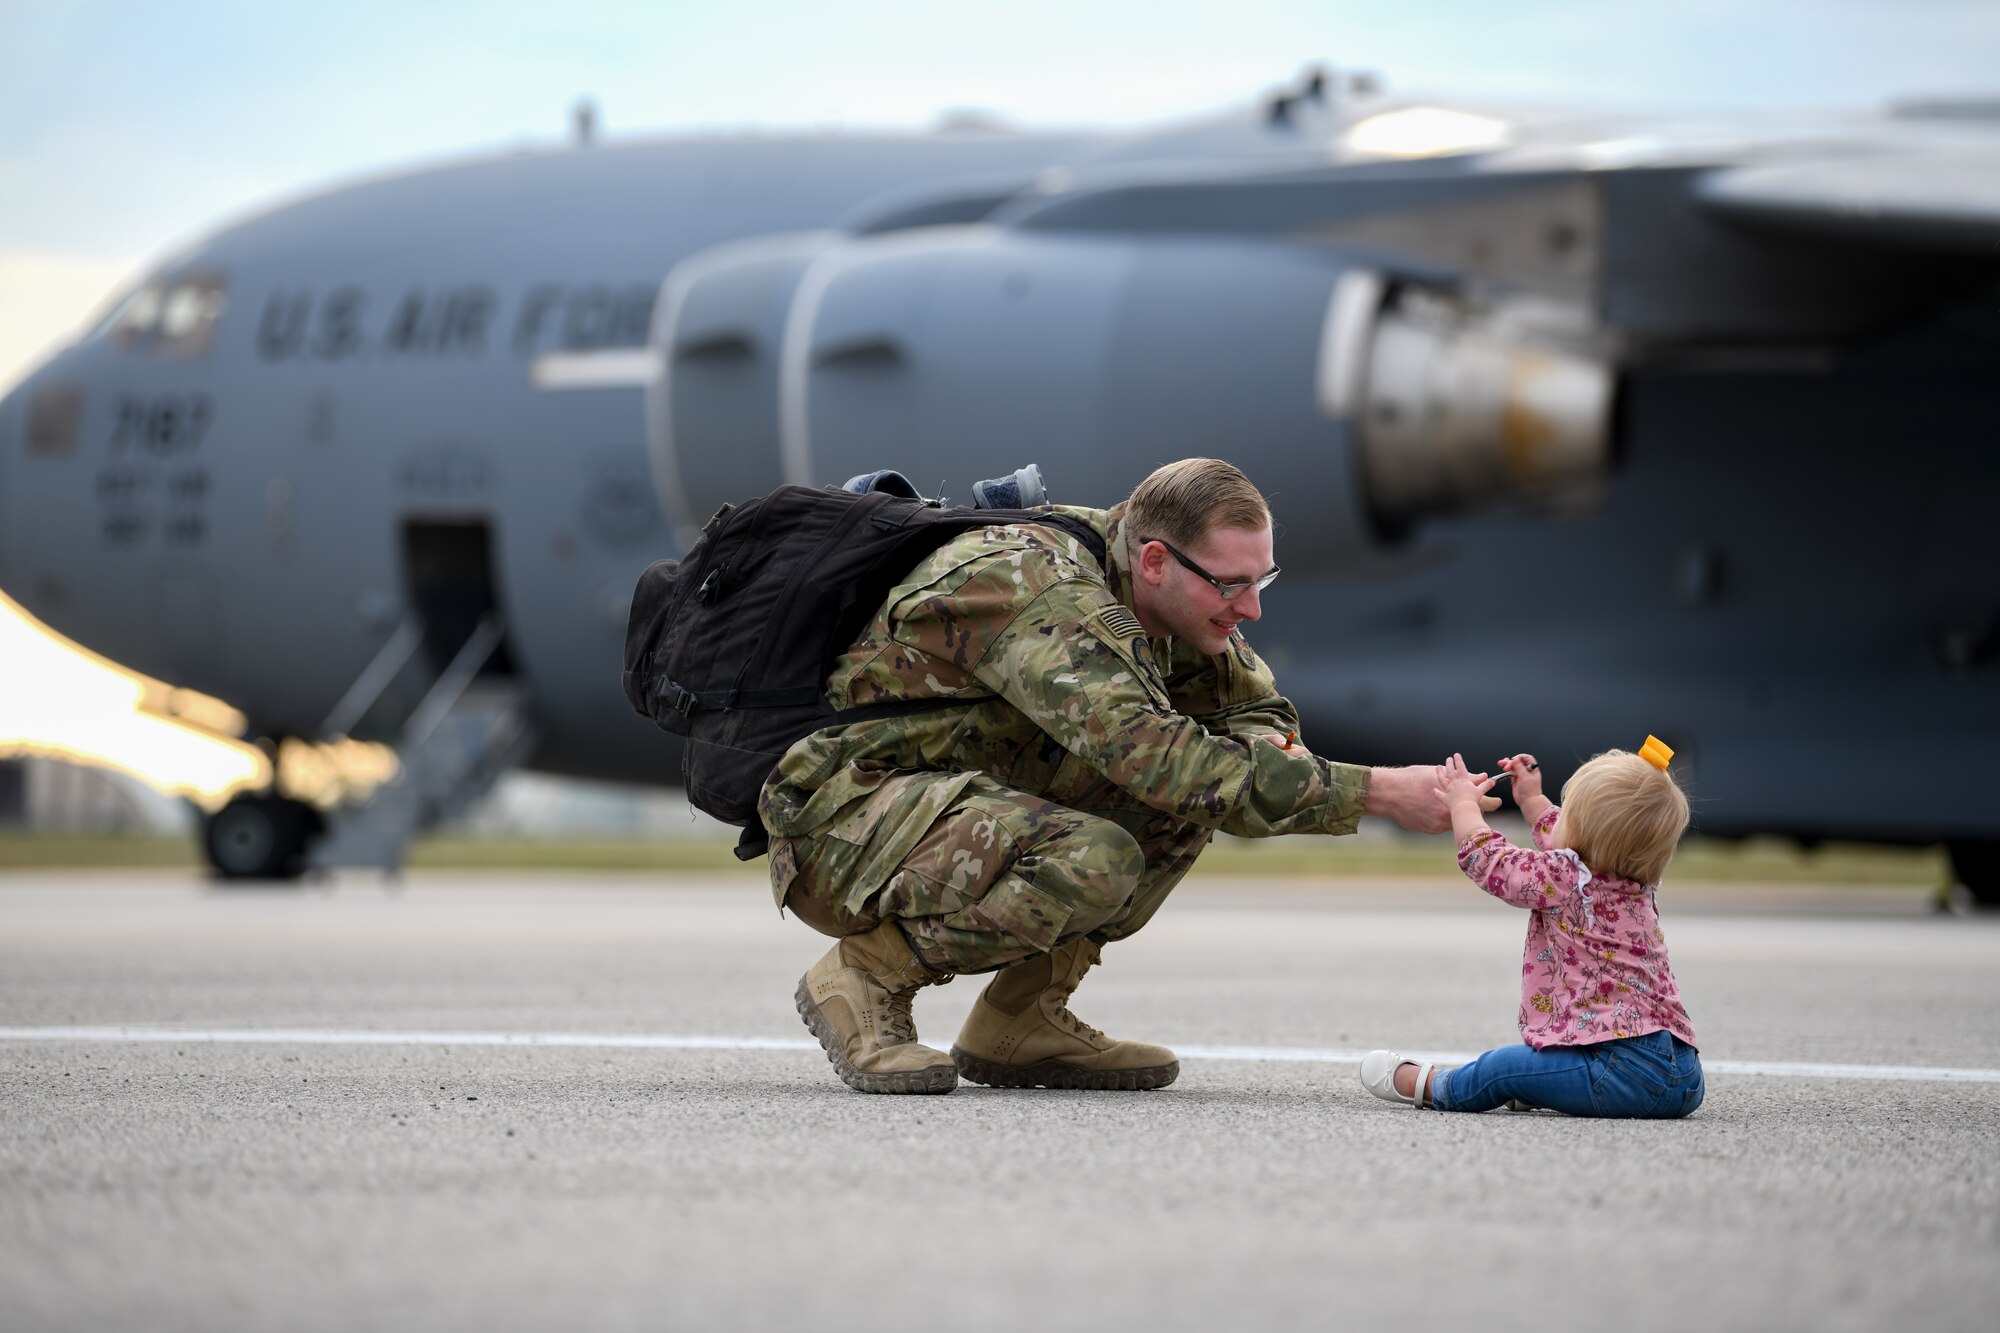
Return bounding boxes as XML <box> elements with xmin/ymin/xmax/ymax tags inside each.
<box><xmin>798</xmin><ymin>921</ymin><xmax>958</xmax><ymax>1093</ymax></box>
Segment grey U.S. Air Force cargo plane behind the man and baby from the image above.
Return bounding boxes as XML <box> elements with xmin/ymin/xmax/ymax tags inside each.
<box><xmin>0</xmin><ymin>72</ymin><xmax>2000</xmax><ymax>903</ymax></box>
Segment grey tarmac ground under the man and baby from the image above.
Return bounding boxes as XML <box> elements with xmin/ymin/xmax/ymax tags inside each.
<box><xmin>0</xmin><ymin>873</ymin><xmax>2000</xmax><ymax>1333</ymax></box>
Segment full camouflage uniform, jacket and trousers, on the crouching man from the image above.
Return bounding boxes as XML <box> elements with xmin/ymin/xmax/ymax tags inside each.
<box><xmin>760</xmin><ymin>506</ymin><xmax>1368</xmax><ymax>973</ymax></box>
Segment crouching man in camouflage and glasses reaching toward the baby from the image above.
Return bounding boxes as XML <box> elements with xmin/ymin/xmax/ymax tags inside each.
<box><xmin>760</xmin><ymin>458</ymin><xmax>1480</xmax><ymax>1093</ymax></box>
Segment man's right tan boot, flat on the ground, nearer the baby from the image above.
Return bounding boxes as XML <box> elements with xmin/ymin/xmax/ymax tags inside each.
<box><xmin>952</xmin><ymin>939</ymin><xmax>1180</xmax><ymax>1091</ymax></box>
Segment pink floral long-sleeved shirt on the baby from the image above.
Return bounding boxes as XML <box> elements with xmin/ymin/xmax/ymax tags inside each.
<box><xmin>1458</xmin><ymin>807</ymin><xmax>1696</xmax><ymax>1051</ymax></box>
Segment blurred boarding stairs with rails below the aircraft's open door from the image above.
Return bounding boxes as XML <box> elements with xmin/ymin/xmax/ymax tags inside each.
<box><xmin>306</xmin><ymin>614</ymin><xmax>536</xmax><ymax>875</ymax></box>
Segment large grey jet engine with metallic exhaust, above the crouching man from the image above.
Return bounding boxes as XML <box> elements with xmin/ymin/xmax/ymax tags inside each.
<box><xmin>648</xmin><ymin>224</ymin><xmax>1610</xmax><ymax>570</ymax></box>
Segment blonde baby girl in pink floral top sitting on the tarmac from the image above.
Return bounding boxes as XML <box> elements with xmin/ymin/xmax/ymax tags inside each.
<box><xmin>1362</xmin><ymin>737</ymin><xmax>1702</xmax><ymax>1117</ymax></box>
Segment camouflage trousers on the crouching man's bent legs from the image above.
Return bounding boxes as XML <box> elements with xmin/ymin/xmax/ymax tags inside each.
<box><xmin>772</xmin><ymin>775</ymin><xmax>1210</xmax><ymax>973</ymax></box>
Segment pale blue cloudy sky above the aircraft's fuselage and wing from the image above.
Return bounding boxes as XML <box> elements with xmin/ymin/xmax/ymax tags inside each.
<box><xmin>0</xmin><ymin>0</ymin><xmax>2000</xmax><ymax>384</ymax></box>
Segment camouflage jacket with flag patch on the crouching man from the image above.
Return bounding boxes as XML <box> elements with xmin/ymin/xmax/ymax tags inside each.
<box><xmin>762</xmin><ymin>506</ymin><xmax>1368</xmax><ymax>903</ymax></box>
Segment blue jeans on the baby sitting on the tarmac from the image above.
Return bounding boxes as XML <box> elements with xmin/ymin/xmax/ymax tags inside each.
<box><xmin>1430</xmin><ymin>1033</ymin><xmax>1702</xmax><ymax>1119</ymax></box>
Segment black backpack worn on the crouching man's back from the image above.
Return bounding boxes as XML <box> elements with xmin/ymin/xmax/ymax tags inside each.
<box><xmin>624</xmin><ymin>486</ymin><xmax>1104</xmax><ymax>861</ymax></box>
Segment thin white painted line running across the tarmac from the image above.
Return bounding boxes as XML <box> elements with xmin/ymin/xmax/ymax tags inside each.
<box><xmin>0</xmin><ymin>1027</ymin><xmax>2000</xmax><ymax>1083</ymax></box>
